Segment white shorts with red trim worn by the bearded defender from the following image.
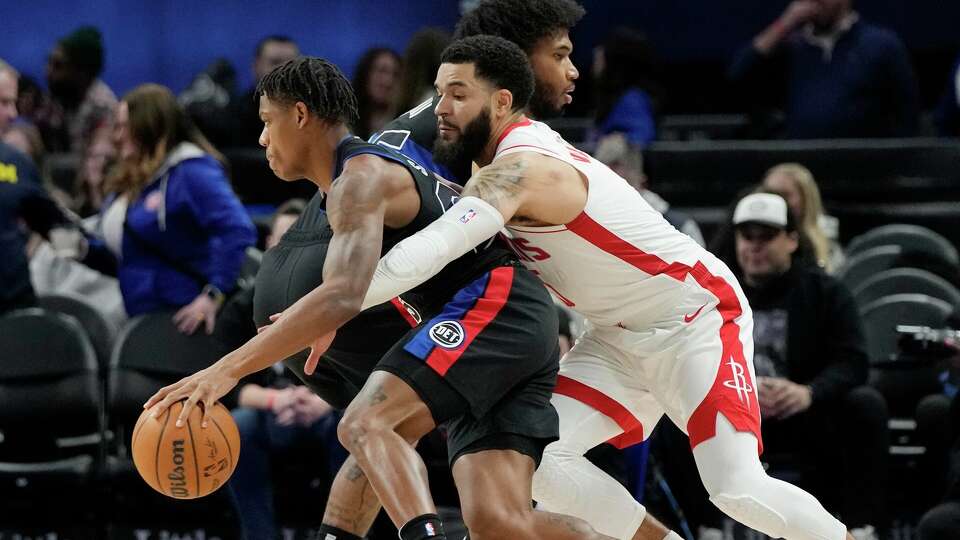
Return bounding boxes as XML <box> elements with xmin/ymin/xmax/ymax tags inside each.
<box><xmin>554</xmin><ymin>291</ymin><xmax>763</xmax><ymax>452</ymax></box>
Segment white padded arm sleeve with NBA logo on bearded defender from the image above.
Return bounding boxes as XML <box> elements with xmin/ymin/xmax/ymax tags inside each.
<box><xmin>363</xmin><ymin>197</ymin><xmax>503</xmax><ymax>309</ymax></box>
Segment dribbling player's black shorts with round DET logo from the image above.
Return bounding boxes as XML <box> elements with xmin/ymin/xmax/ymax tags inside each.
<box><xmin>376</xmin><ymin>266</ymin><xmax>559</xmax><ymax>464</ymax></box>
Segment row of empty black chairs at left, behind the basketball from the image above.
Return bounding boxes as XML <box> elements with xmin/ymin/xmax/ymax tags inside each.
<box><xmin>0</xmin><ymin>308</ymin><xmax>238</xmax><ymax>530</ymax></box>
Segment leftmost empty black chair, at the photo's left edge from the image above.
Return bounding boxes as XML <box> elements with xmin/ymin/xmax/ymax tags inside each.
<box><xmin>0</xmin><ymin>308</ymin><xmax>103</xmax><ymax>530</ymax></box>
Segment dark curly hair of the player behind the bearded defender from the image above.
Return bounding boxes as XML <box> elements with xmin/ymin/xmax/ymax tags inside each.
<box><xmin>453</xmin><ymin>0</ymin><xmax>586</xmax><ymax>54</ymax></box>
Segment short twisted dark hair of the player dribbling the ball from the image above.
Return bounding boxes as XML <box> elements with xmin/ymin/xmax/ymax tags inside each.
<box><xmin>257</xmin><ymin>56</ymin><xmax>357</xmax><ymax>125</ymax></box>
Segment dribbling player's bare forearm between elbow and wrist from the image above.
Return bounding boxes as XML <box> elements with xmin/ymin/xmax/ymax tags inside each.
<box><xmin>220</xmin><ymin>284</ymin><xmax>360</xmax><ymax>378</ymax></box>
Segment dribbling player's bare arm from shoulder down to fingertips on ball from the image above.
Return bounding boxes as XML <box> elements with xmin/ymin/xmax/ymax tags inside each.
<box><xmin>144</xmin><ymin>158</ymin><xmax>391</xmax><ymax>423</ymax></box>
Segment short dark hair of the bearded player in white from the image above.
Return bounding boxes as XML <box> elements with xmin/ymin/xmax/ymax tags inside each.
<box><xmin>440</xmin><ymin>36</ymin><xmax>534</xmax><ymax>111</ymax></box>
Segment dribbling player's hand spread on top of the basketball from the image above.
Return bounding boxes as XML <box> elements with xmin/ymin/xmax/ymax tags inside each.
<box><xmin>143</xmin><ymin>363</ymin><xmax>239</xmax><ymax>428</ymax></box>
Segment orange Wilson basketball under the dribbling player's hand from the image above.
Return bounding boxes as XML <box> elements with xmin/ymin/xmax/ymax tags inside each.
<box><xmin>130</xmin><ymin>401</ymin><xmax>240</xmax><ymax>499</ymax></box>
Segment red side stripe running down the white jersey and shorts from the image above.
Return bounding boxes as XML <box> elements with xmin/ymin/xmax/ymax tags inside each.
<box><xmin>567</xmin><ymin>212</ymin><xmax>763</xmax><ymax>452</ymax></box>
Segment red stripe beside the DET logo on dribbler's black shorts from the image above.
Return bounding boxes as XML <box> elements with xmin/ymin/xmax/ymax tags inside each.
<box><xmin>427</xmin><ymin>266</ymin><xmax>513</xmax><ymax>376</ymax></box>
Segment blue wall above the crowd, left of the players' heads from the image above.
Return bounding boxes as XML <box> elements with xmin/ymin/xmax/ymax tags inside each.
<box><xmin>0</xmin><ymin>0</ymin><xmax>459</xmax><ymax>94</ymax></box>
